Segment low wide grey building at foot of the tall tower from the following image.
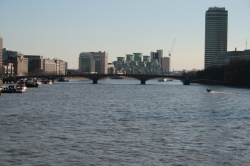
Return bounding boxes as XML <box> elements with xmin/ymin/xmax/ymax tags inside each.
<box><xmin>211</xmin><ymin>49</ymin><xmax>250</xmax><ymax>66</ymax></box>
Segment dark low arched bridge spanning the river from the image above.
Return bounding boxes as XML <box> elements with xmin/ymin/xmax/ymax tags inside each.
<box><xmin>3</xmin><ymin>74</ymin><xmax>190</xmax><ymax>85</ymax></box>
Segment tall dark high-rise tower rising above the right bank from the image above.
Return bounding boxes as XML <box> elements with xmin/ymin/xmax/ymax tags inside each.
<box><xmin>205</xmin><ymin>7</ymin><xmax>228</xmax><ymax>68</ymax></box>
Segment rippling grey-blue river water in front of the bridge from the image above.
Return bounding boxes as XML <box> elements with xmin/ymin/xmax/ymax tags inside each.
<box><xmin>0</xmin><ymin>80</ymin><xmax>250</xmax><ymax>166</ymax></box>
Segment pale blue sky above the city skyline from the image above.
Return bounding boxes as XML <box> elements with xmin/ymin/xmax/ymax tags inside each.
<box><xmin>0</xmin><ymin>0</ymin><xmax>250</xmax><ymax>70</ymax></box>
